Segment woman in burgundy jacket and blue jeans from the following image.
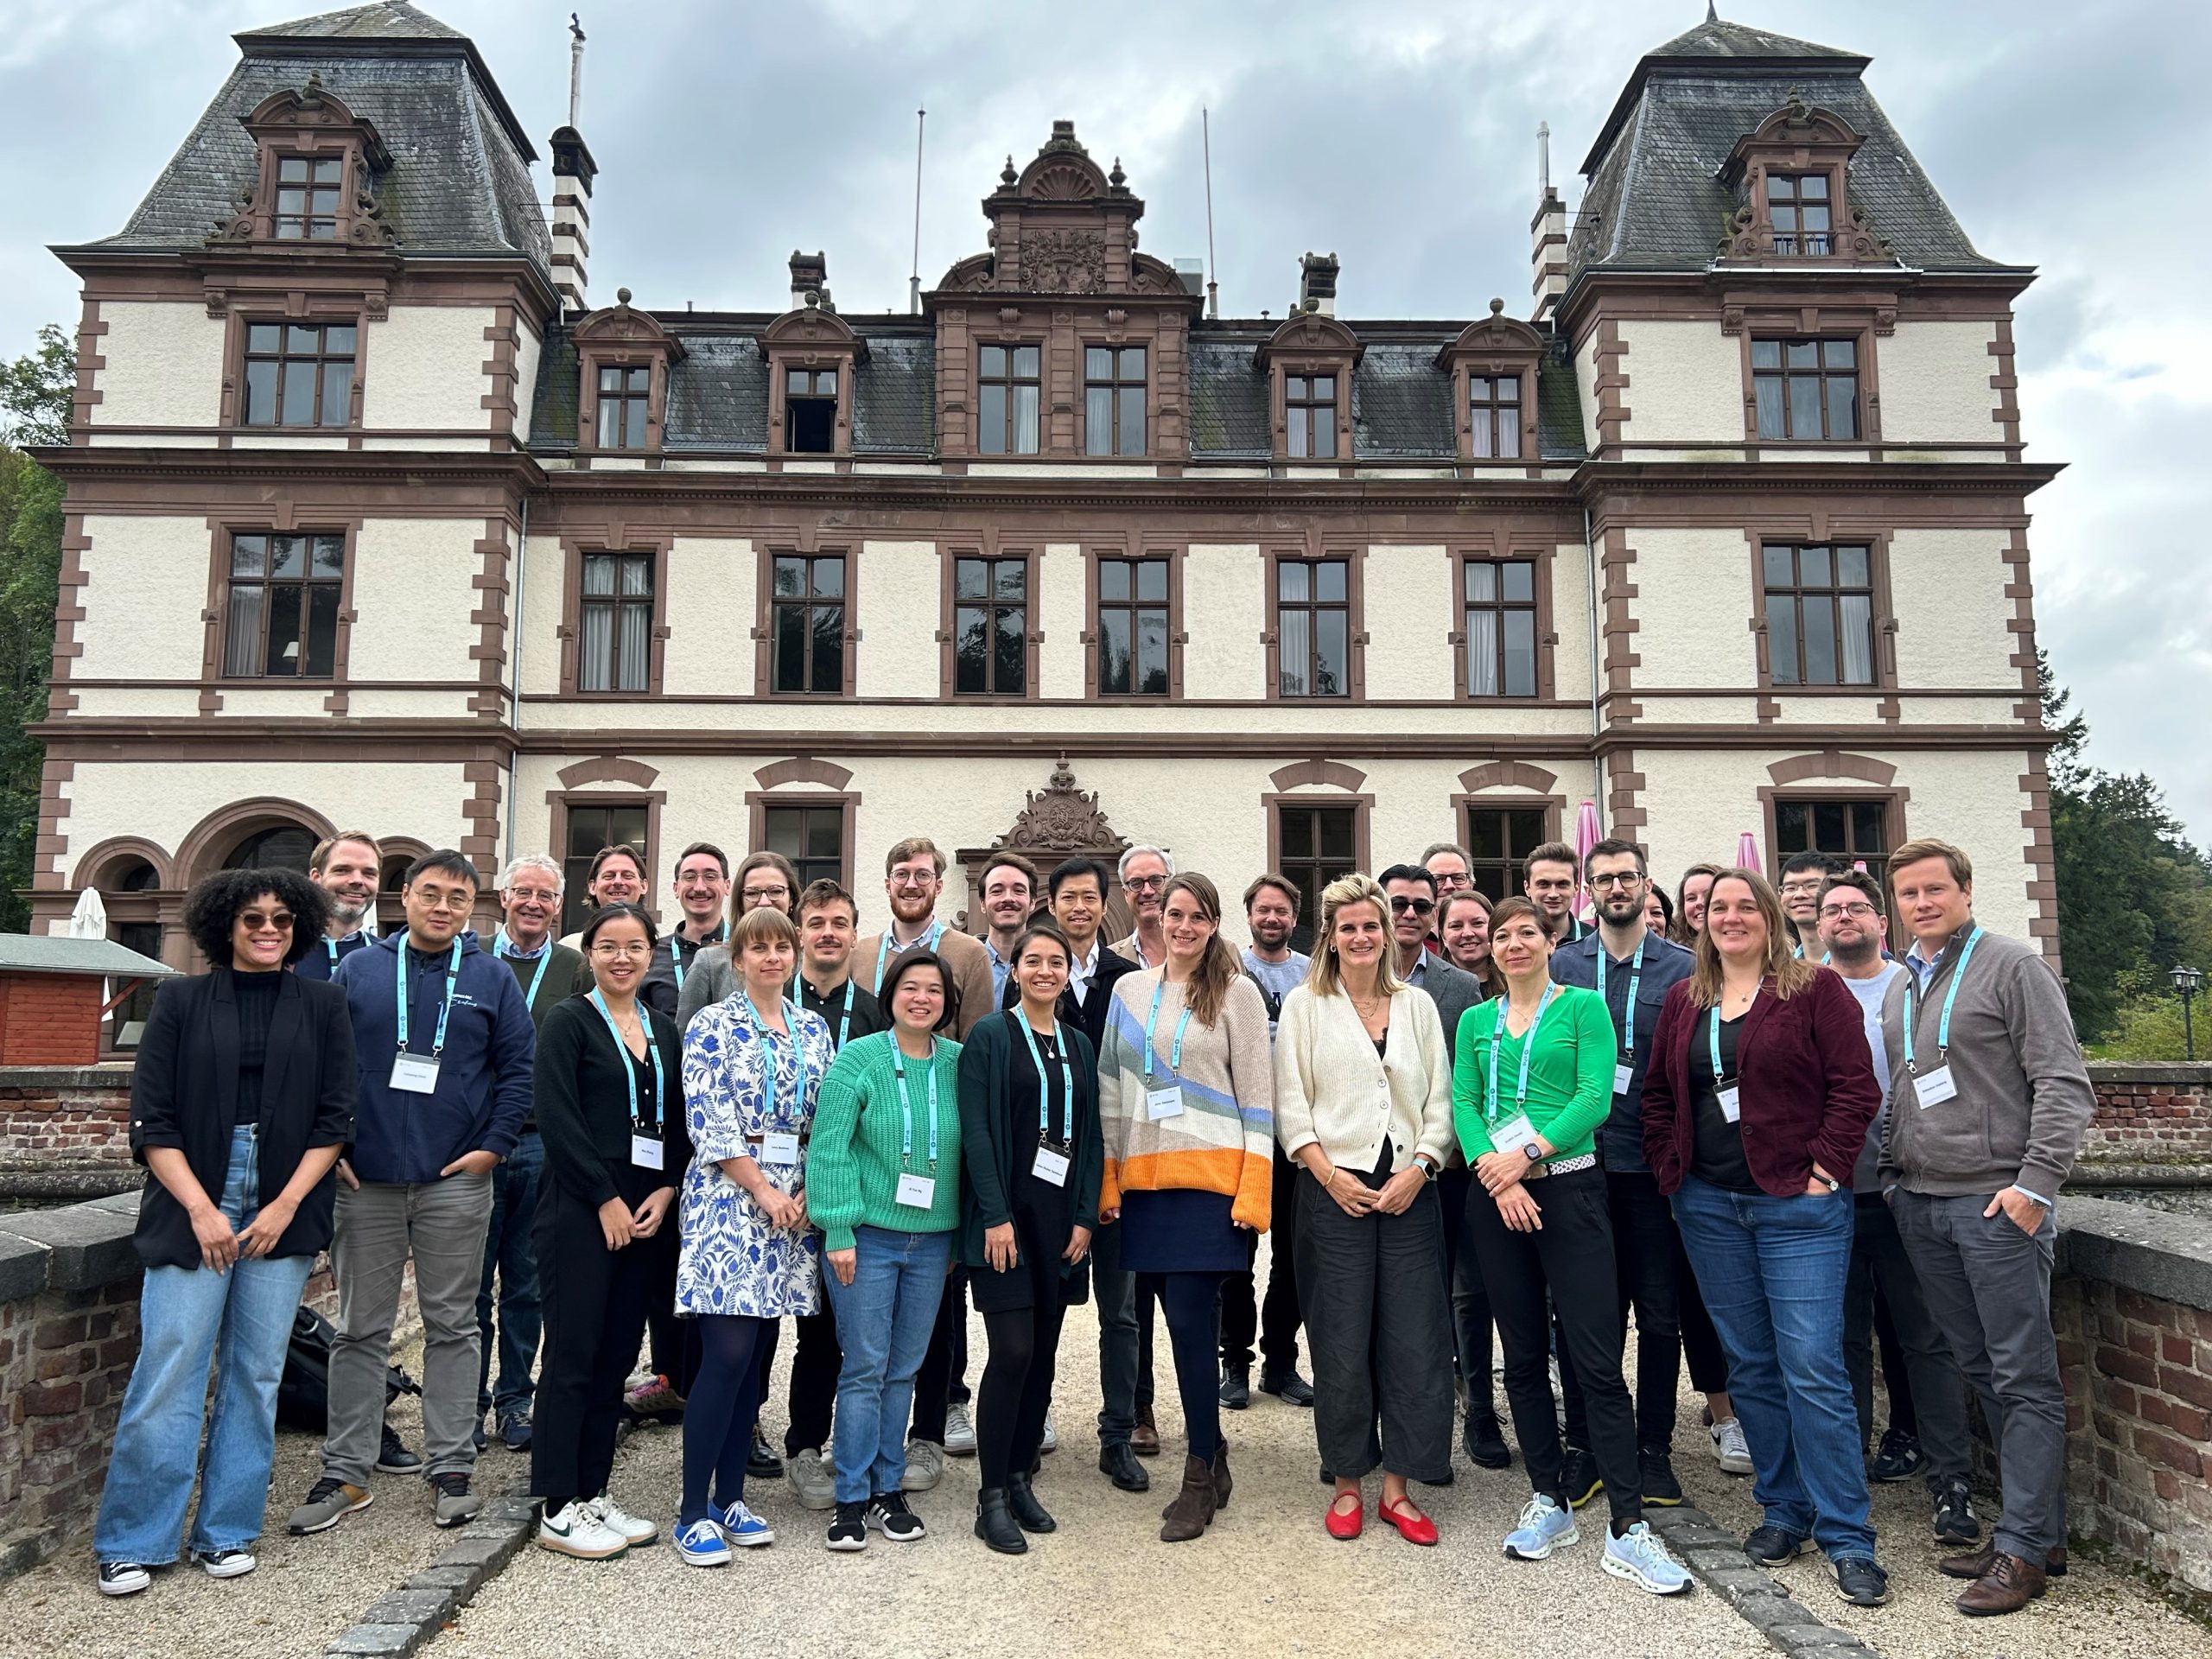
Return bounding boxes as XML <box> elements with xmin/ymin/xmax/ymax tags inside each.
<box><xmin>1643</xmin><ymin>869</ymin><xmax>1889</xmax><ymax>1606</ymax></box>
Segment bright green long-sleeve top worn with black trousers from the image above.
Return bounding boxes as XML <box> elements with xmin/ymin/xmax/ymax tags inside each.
<box><xmin>1451</xmin><ymin>984</ymin><xmax>1621</xmax><ymax>1164</ymax></box>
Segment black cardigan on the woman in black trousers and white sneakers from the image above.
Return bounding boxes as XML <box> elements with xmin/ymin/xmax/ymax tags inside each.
<box><xmin>531</xmin><ymin>995</ymin><xmax>692</xmax><ymax>1210</ymax></box>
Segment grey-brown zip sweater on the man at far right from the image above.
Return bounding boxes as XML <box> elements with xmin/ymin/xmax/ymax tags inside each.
<box><xmin>1883</xmin><ymin>929</ymin><xmax>2097</xmax><ymax>1199</ymax></box>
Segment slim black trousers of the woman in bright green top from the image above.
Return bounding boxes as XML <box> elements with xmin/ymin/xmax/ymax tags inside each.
<box><xmin>1466</xmin><ymin>1168</ymin><xmax>1643</xmax><ymax>1526</ymax></box>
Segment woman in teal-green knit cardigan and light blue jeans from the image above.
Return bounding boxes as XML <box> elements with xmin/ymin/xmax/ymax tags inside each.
<box><xmin>807</xmin><ymin>949</ymin><xmax>960</xmax><ymax>1551</ymax></box>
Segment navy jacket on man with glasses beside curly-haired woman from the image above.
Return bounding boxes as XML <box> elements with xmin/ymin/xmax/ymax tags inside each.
<box><xmin>332</xmin><ymin>931</ymin><xmax>537</xmax><ymax>1181</ymax></box>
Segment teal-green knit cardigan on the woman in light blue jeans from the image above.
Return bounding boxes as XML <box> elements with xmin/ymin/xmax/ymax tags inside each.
<box><xmin>807</xmin><ymin>1031</ymin><xmax>960</xmax><ymax>1249</ymax></box>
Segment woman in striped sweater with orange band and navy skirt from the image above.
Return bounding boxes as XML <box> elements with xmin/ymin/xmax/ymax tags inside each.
<box><xmin>1099</xmin><ymin>876</ymin><xmax>1274</xmax><ymax>1544</ymax></box>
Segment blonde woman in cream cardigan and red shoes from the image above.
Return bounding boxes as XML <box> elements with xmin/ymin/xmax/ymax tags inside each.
<box><xmin>1274</xmin><ymin>876</ymin><xmax>1459</xmax><ymax>1544</ymax></box>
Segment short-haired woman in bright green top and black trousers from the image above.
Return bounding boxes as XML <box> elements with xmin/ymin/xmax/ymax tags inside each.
<box><xmin>1451</xmin><ymin>898</ymin><xmax>1690</xmax><ymax>1595</ymax></box>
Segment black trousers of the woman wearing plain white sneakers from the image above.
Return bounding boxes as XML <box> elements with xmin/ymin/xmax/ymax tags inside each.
<box><xmin>531</xmin><ymin>1164</ymin><xmax>677</xmax><ymax>1500</ymax></box>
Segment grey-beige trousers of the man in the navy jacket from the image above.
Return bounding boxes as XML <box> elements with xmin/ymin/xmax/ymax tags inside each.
<box><xmin>323</xmin><ymin>1174</ymin><xmax>491</xmax><ymax>1486</ymax></box>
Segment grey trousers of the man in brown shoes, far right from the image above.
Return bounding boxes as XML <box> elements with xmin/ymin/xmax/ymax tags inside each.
<box><xmin>1893</xmin><ymin>1188</ymin><xmax>2066</xmax><ymax>1564</ymax></box>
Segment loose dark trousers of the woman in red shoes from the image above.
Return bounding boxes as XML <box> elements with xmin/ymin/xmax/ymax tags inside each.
<box><xmin>1296</xmin><ymin>1170</ymin><xmax>1459</xmax><ymax>1482</ymax></box>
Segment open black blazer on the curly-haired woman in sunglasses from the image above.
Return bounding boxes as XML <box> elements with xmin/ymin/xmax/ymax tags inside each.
<box><xmin>130</xmin><ymin>967</ymin><xmax>359</xmax><ymax>1268</ymax></box>
